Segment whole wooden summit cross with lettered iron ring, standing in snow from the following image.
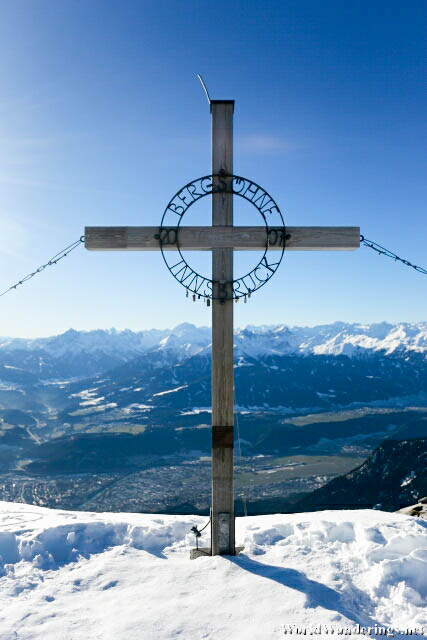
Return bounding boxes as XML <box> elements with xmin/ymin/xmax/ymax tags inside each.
<box><xmin>85</xmin><ymin>95</ymin><xmax>360</xmax><ymax>555</ymax></box>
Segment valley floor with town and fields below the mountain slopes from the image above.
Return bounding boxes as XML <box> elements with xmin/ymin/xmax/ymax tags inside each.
<box><xmin>0</xmin><ymin>406</ymin><xmax>427</xmax><ymax>515</ymax></box>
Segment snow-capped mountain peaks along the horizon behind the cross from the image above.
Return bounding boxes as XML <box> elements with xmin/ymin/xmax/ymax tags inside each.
<box><xmin>0</xmin><ymin>322</ymin><xmax>427</xmax><ymax>379</ymax></box>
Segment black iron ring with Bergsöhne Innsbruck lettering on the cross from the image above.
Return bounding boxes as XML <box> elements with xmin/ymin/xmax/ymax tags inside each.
<box><xmin>156</xmin><ymin>175</ymin><xmax>286</xmax><ymax>300</ymax></box>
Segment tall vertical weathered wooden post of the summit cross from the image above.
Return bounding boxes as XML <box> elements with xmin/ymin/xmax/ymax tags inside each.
<box><xmin>211</xmin><ymin>100</ymin><xmax>235</xmax><ymax>555</ymax></box>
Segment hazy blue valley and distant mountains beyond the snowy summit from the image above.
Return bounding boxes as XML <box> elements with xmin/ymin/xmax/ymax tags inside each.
<box><xmin>0</xmin><ymin>323</ymin><xmax>427</xmax><ymax>514</ymax></box>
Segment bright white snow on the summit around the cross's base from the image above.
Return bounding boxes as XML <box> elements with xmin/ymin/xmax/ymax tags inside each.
<box><xmin>0</xmin><ymin>502</ymin><xmax>427</xmax><ymax>640</ymax></box>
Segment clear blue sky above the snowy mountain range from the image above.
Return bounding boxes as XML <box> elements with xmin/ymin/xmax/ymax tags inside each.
<box><xmin>0</xmin><ymin>0</ymin><xmax>427</xmax><ymax>337</ymax></box>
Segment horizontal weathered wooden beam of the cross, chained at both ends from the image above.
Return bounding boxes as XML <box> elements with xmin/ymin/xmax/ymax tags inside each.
<box><xmin>85</xmin><ymin>227</ymin><xmax>360</xmax><ymax>251</ymax></box>
